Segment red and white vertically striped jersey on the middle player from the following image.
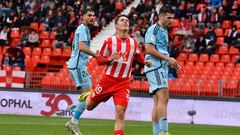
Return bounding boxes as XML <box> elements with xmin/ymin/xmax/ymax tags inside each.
<box><xmin>100</xmin><ymin>35</ymin><xmax>140</xmax><ymax>78</ymax></box>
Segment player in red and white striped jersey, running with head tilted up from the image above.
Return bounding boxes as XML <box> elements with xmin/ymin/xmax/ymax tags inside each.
<box><xmin>80</xmin><ymin>15</ymin><xmax>151</xmax><ymax>135</ymax></box>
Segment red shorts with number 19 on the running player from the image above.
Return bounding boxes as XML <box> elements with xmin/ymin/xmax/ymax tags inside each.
<box><xmin>90</xmin><ymin>75</ymin><xmax>130</xmax><ymax>107</ymax></box>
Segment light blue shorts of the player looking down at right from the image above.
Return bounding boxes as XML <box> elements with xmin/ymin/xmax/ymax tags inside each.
<box><xmin>146</xmin><ymin>67</ymin><xmax>168</xmax><ymax>95</ymax></box>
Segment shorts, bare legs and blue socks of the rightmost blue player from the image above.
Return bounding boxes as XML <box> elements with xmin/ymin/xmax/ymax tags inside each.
<box><xmin>146</xmin><ymin>68</ymin><xmax>168</xmax><ymax>135</ymax></box>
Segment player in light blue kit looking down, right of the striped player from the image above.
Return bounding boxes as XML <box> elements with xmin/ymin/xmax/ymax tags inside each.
<box><xmin>144</xmin><ymin>5</ymin><xmax>181</xmax><ymax>135</ymax></box>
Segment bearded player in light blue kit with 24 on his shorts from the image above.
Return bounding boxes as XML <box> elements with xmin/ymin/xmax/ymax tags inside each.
<box><xmin>65</xmin><ymin>8</ymin><xmax>98</xmax><ymax>135</ymax></box>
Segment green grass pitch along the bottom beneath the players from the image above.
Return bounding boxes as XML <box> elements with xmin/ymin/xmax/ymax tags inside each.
<box><xmin>0</xmin><ymin>115</ymin><xmax>240</xmax><ymax>135</ymax></box>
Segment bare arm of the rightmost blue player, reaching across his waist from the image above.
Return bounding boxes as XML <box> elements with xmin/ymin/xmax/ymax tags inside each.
<box><xmin>145</xmin><ymin>43</ymin><xmax>181</xmax><ymax>70</ymax></box>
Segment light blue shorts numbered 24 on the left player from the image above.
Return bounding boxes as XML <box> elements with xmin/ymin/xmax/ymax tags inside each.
<box><xmin>69</xmin><ymin>68</ymin><xmax>92</xmax><ymax>90</ymax></box>
